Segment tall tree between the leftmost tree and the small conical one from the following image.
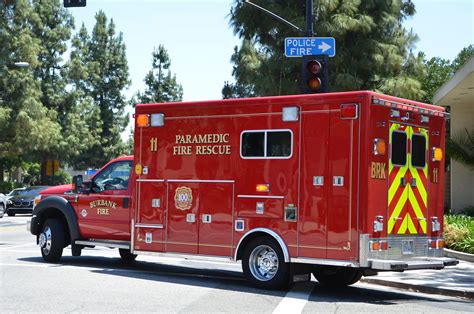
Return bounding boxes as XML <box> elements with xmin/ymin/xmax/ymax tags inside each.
<box><xmin>68</xmin><ymin>11</ymin><xmax>130</xmax><ymax>167</ymax></box>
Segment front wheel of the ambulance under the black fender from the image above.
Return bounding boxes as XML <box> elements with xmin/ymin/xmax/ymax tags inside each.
<box><xmin>38</xmin><ymin>219</ymin><xmax>64</xmax><ymax>263</ymax></box>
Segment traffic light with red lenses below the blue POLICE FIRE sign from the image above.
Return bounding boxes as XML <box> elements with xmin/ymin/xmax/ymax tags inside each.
<box><xmin>301</xmin><ymin>55</ymin><xmax>329</xmax><ymax>94</ymax></box>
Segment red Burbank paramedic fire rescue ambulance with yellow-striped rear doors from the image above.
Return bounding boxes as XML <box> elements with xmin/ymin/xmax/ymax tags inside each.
<box><xmin>31</xmin><ymin>91</ymin><xmax>457</xmax><ymax>288</ymax></box>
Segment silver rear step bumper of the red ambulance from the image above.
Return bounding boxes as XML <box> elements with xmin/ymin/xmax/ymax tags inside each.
<box><xmin>368</xmin><ymin>257</ymin><xmax>459</xmax><ymax>271</ymax></box>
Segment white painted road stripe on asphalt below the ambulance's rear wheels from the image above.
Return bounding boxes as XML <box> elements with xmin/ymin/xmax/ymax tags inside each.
<box><xmin>273</xmin><ymin>282</ymin><xmax>314</xmax><ymax>314</ymax></box>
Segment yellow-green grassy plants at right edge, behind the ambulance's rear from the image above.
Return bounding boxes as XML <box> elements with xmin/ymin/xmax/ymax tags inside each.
<box><xmin>444</xmin><ymin>215</ymin><xmax>474</xmax><ymax>254</ymax></box>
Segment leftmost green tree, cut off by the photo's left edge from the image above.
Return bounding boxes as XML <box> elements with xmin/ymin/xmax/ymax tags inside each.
<box><xmin>0</xmin><ymin>0</ymin><xmax>61</xmax><ymax>179</ymax></box>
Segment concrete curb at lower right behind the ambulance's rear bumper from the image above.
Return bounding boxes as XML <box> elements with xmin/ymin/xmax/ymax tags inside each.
<box><xmin>360</xmin><ymin>278</ymin><xmax>474</xmax><ymax>300</ymax></box>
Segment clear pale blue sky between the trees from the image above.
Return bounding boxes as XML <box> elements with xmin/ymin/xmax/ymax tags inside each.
<box><xmin>69</xmin><ymin>0</ymin><xmax>474</xmax><ymax>134</ymax></box>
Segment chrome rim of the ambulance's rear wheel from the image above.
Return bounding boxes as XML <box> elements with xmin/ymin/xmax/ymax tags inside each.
<box><xmin>249</xmin><ymin>245</ymin><xmax>279</xmax><ymax>281</ymax></box>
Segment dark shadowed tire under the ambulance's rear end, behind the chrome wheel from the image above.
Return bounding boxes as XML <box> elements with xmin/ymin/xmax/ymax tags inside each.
<box><xmin>313</xmin><ymin>267</ymin><xmax>362</xmax><ymax>288</ymax></box>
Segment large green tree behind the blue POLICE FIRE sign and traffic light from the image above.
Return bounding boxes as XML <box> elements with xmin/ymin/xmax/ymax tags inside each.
<box><xmin>223</xmin><ymin>0</ymin><xmax>424</xmax><ymax>99</ymax></box>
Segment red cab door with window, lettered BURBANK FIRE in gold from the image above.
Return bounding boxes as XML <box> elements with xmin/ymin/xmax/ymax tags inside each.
<box><xmin>76</xmin><ymin>160</ymin><xmax>133</xmax><ymax>240</ymax></box>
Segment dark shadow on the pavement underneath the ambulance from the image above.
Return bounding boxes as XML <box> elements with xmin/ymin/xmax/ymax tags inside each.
<box><xmin>18</xmin><ymin>256</ymin><xmax>470</xmax><ymax>305</ymax></box>
